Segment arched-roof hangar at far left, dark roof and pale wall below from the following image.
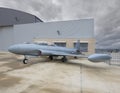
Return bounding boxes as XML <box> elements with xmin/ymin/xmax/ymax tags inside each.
<box><xmin>0</xmin><ymin>8</ymin><xmax>43</xmax><ymax>51</ymax></box>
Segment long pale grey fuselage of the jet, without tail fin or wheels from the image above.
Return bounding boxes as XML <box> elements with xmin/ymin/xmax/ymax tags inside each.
<box><xmin>8</xmin><ymin>44</ymin><xmax>77</xmax><ymax>56</ymax></box>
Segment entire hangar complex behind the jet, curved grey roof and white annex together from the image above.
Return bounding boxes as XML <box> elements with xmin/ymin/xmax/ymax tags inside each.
<box><xmin>0</xmin><ymin>8</ymin><xmax>95</xmax><ymax>54</ymax></box>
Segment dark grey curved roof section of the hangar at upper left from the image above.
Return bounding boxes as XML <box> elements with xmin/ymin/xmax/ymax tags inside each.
<box><xmin>0</xmin><ymin>7</ymin><xmax>43</xmax><ymax>26</ymax></box>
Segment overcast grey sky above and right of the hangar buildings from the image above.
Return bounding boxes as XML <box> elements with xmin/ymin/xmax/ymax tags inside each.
<box><xmin>0</xmin><ymin>0</ymin><xmax>120</xmax><ymax>48</ymax></box>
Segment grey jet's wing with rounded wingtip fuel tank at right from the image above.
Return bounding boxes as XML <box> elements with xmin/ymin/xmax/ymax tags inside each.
<box><xmin>40</xmin><ymin>50</ymin><xmax>112</xmax><ymax>62</ymax></box>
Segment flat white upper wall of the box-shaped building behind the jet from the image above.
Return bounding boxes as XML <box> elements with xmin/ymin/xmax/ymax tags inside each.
<box><xmin>14</xmin><ymin>19</ymin><xmax>94</xmax><ymax>43</ymax></box>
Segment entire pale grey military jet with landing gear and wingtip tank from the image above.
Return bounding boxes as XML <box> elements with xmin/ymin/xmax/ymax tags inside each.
<box><xmin>8</xmin><ymin>40</ymin><xmax>111</xmax><ymax>64</ymax></box>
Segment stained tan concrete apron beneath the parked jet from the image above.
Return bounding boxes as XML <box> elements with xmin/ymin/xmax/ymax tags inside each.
<box><xmin>0</xmin><ymin>53</ymin><xmax>120</xmax><ymax>93</ymax></box>
